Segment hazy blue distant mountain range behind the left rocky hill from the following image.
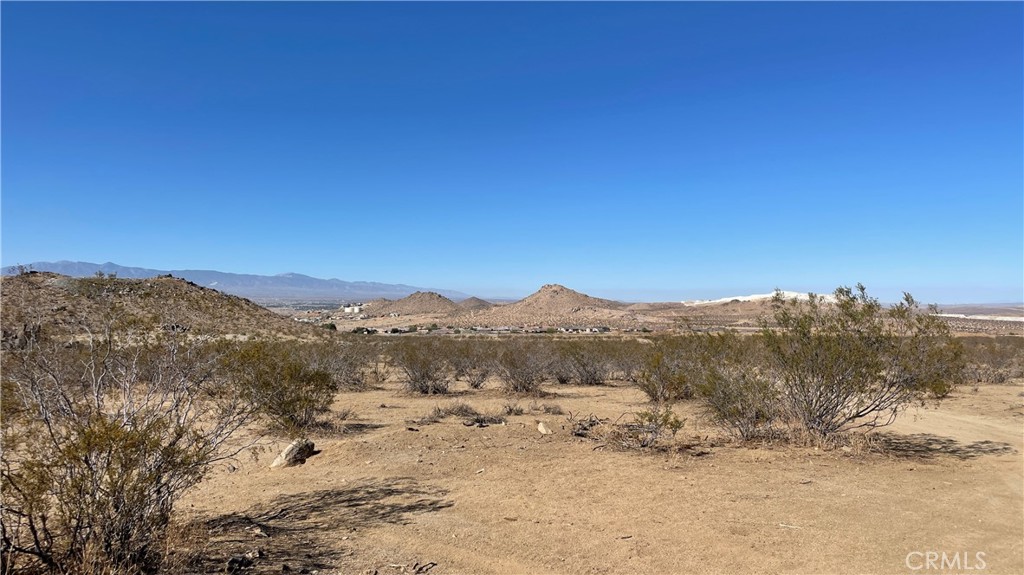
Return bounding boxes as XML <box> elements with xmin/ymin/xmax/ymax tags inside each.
<box><xmin>0</xmin><ymin>261</ymin><xmax>469</xmax><ymax>303</ymax></box>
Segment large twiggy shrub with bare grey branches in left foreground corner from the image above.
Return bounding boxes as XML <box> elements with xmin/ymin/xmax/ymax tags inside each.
<box><xmin>0</xmin><ymin>309</ymin><xmax>256</xmax><ymax>575</ymax></box>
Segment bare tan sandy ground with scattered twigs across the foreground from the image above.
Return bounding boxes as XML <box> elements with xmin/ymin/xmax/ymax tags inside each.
<box><xmin>179</xmin><ymin>381</ymin><xmax>1024</xmax><ymax>575</ymax></box>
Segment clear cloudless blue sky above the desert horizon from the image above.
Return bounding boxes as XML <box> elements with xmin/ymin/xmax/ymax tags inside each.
<box><xmin>0</xmin><ymin>2</ymin><xmax>1024</xmax><ymax>303</ymax></box>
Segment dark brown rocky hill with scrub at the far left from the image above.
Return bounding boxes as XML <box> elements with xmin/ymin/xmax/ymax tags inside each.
<box><xmin>0</xmin><ymin>272</ymin><xmax>324</xmax><ymax>338</ymax></box>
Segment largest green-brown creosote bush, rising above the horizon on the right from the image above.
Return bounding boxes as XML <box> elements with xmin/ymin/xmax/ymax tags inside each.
<box><xmin>761</xmin><ymin>285</ymin><xmax>965</xmax><ymax>437</ymax></box>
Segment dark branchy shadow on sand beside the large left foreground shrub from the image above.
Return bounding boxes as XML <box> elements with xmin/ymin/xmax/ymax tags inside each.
<box><xmin>196</xmin><ymin>477</ymin><xmax>455</xmax><ymax>573</ymax></box>
